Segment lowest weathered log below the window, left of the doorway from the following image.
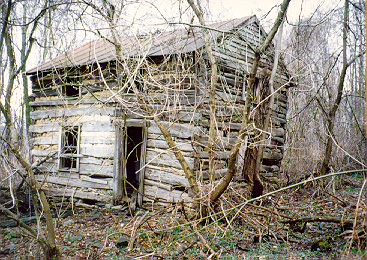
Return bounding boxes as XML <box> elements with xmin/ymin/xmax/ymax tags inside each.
<box><xmin>42</xmin><ymin>187</ymin><xmax>112</xmax><ymax>203</ymax></box>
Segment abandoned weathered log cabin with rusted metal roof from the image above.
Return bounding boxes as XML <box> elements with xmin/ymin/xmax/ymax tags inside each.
<box><xmin>27</xmin><ymin>16</ymin><xmax>291</xmax><ymax>205</ymax></box>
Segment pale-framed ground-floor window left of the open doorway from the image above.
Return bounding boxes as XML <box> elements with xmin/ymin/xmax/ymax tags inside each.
<box><xmin>59</xmin><ymin>126</ymin><xmax>80</xmax><ymax>172</ymax></box>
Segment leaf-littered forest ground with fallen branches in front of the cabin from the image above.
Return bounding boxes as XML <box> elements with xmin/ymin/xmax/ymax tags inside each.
<box><xmin>0</xmin><ymin>175</ymin><xmax>367</xmax><ymax>259</ymax></box>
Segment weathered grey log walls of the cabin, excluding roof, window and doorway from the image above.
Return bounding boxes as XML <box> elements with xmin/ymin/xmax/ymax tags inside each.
<box><xmin>30</xmin><ymin>15</ymin><xmax>289</xmax><ymax>202</ymax></box>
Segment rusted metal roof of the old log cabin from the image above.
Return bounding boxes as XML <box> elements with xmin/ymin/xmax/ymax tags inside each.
<box><xmin>26</xmin><ymin>16</ymin><xmax>257</xmax><ymax>74</ymax></box>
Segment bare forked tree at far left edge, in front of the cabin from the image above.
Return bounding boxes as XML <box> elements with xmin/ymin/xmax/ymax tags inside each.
<box><xmin>0</xmin><ymin>0</ymin><xmax>58</xmax><ymax>259</ymax></box>
